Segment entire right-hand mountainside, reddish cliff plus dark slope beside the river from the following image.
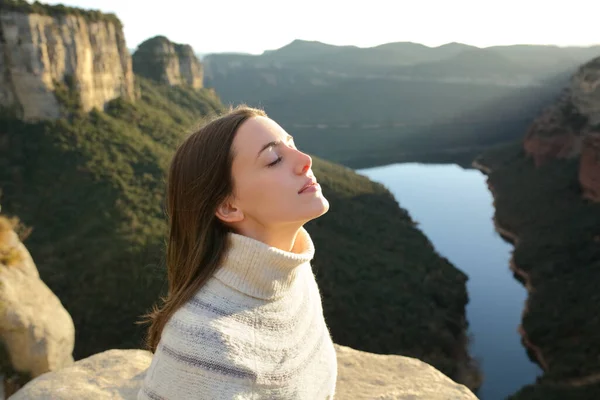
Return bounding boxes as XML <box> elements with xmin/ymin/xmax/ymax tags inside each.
<box><xmin>475</xmin><ymin>54</ymin><xmax>600</xmax><ymax>400</ymax></box>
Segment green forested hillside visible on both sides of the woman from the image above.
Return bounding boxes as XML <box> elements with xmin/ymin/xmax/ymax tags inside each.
<box><xmin>0</xmin><ymin>77</ymin><xmax>477</xmax><ymax>386</ymax></box>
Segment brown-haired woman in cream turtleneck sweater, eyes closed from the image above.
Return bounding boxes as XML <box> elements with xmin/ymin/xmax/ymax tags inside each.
<box><xmin>138</xmin><ymin>106</ymin><xmax>337</xmax><ymax>400</ymax></box>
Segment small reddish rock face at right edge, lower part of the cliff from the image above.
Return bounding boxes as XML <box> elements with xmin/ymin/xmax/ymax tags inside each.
<box><xmin>579</xmin><ymin>132</ymin><xmax>600</xmax><ymax>202</ymax></box>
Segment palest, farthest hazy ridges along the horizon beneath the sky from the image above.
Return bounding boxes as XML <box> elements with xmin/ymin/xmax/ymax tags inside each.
<box><xmin>205</xmin><ymin>40</ymin><xmax>600</xmax><ymax>81</ymax></box>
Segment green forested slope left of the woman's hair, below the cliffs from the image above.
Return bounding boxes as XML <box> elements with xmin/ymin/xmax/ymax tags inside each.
<box><xmin>0</xmin><ymin>78</ymin><xmax>222</xmax><ymax>358</ymax></box>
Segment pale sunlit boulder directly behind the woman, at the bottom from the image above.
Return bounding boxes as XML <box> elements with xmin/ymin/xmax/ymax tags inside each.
<box><xmin>10</xmin><ymin>345</ymin><xmax>477</xmax><ymax>400</ymax></box>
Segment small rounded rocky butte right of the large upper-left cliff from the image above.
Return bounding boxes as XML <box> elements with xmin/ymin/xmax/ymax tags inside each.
<box><xmin>133</xmin><ymin>36</ymin><xmax>203</xmax><ymax>89</ymax></box>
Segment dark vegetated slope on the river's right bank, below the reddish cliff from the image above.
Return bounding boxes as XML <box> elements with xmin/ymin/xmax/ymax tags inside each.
<box><xmin>481</xmin><ymin>144</ymin><xmax>600</xmax><ymax>399</ymax></box>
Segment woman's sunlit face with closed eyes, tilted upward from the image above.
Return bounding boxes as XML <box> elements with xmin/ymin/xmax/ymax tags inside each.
<box><xmin>224</xmin><ymin>117</ymin><xmax>329</xmax><ymax>228</ymax></box>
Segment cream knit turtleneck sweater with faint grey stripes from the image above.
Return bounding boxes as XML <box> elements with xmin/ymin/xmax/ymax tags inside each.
<box><xmin>138</xmin><ymin>228</ymin><xmax>337</xmax><ymax>400</ymax></box>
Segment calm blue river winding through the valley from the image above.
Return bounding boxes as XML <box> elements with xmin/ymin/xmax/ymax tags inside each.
<box><xmin>356</xmin><ymin>163</ymin><xmax>542</xmax><ymax>400</ymax></box>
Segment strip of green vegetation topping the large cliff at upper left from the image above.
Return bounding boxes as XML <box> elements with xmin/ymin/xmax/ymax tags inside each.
<box><xmin>0</xmin><ymin>0</ymin><xmax>123</xmax><ymax>29</ymax></box>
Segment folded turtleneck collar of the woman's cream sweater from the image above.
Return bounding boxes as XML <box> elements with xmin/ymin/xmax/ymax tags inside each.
<box><xmin>214</xmin><ymin>227</ymin><xmax>315</xmax><ymax>300</ymax></box>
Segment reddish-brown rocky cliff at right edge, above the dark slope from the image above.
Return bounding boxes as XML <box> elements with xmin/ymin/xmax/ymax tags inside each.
<box><xmin>523</xmin><ymin>57</ymin><xmax>600</xmax><ymax>201</ymax></box>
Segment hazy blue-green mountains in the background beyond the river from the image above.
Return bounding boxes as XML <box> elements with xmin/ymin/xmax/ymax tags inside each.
<box><xmin>204</xmin><ymin>41</ymin><xmax>600</xmax><ymax>167</ymax></box>
